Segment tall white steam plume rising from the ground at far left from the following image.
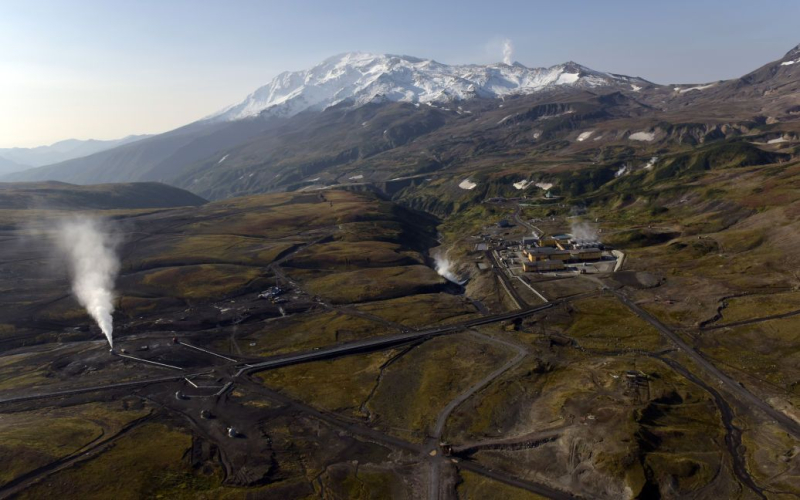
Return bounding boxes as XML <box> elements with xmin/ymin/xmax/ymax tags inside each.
<box><xmin>55</xmin><ymin>218</ymin><xmax>119</xmax><ymax>348</ymax></box>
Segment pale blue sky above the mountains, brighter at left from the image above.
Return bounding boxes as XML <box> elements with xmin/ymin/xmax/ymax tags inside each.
<box><xmin>0</xmin><ymin>0</ymin><xmax>800</xmax><ymax>147</ymax></box>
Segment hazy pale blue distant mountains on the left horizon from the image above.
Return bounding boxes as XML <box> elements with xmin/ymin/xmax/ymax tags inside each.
<box><xmin>0</xmin><ymin>135</ymin><xmax>149</xmax><ymax>173</ymax></box>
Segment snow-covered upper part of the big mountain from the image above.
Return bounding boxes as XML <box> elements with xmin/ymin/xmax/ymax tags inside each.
<box><xmin>209</xmin><ymin>52</ymin><xmax>652</xmax><ymax>121</ymax></box>
